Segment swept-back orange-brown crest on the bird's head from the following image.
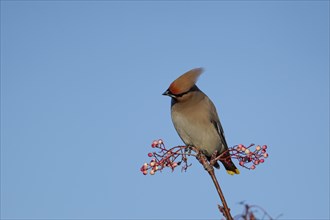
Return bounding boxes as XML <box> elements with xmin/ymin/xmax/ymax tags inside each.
<box><xmin>169</xmin><ymin>68</ymin><xmax>203</xmax><ymax>95</ymax></box>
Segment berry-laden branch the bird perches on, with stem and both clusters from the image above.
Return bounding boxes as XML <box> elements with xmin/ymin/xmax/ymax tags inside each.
<box><xmin>140</xmin><ymin>139</ymin><xmax>268</xmax><ymax>220</ymax></box>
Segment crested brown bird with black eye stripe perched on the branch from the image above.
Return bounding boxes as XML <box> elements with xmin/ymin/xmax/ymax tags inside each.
<box><xmin>162</xmin><ymin>68</ymin><xmax>240</xmax><ymax>175</ymax></box>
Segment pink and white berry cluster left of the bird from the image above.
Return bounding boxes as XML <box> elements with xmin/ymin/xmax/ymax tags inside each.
<box><xmin>140</xmin><ymin>139</ymin><xmax>192</xmax><ymax>175</ymax></box>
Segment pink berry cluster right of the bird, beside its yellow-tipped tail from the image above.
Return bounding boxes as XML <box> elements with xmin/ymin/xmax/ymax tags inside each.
<box><xmin>229</xmin><ymin>144</ymin><xmax>268</xmax><ymax>170</ymax></box>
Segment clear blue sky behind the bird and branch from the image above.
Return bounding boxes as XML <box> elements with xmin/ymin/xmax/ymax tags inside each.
<box><xmin>1</xmin><ymin>1</ymin><xmax>329</xmax><ymax>219</ymax></box>
